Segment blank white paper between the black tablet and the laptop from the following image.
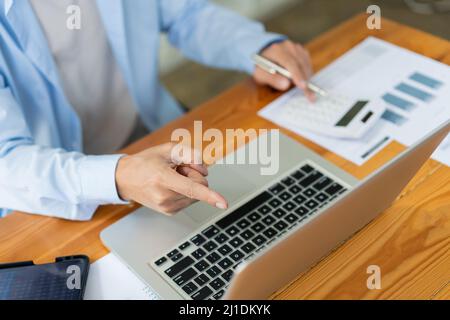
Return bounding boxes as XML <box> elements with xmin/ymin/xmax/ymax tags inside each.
<box><xmin>84</xmin><ymin>253</ymin><xmax>159</xmax><ymax>300</ymax></box>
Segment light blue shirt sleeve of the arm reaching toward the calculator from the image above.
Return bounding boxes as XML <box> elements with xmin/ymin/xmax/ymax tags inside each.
<box><xmin>159</xmin><ymin>0</ymin><xmax>286</xmax><ymax>73</ymax></box>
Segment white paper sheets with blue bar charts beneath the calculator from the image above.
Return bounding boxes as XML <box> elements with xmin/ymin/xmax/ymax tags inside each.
<box><xmin>259</xmin><ymin>37</ymin><xmax>450</xmax><ymax>166</ymax></box>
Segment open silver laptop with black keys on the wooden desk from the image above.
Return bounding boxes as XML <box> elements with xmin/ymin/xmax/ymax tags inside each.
<box><xmin>101</xmin><ymin>121</ymin><xmax>450</xmax><ymax>300</ymax></box>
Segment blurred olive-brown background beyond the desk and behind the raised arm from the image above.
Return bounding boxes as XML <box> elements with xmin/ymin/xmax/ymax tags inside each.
<box><xmin>161</xmin><ymin>0</ymin><xmax>450</xmax><ymax>109</ymax></box>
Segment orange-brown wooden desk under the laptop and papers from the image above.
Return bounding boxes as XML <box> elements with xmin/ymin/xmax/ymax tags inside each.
<box><xmin>0</xmin><ymin>14</ymin><xmax>450</xmax><ymax>299</ymax></box>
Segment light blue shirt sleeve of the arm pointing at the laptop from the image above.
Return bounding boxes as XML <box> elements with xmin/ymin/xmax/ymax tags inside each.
<box><xmin>0</xmin><ymin>83</ymin><xmax>125</xmax><ymax>220</ymax></box>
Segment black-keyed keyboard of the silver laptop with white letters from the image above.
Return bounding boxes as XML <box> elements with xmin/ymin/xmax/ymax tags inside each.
<box><xmin>152</xmin><ymin>164</ymin><xmax>347</xmax><ymax>300</ymax></box>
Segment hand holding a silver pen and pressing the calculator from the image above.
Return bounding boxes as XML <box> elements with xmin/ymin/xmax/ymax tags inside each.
<box><xmin>253</xmin><ymin>40</ymin><xmax>314</xmax><ymax>101</ymax></box>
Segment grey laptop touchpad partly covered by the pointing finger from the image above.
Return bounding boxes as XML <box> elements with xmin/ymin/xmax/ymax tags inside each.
<box><xmin>183</xmin><ymin>165</ymin><xmax>255</xmax><ymax>224</ymax></box>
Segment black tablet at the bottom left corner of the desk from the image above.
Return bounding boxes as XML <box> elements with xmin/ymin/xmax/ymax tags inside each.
<box><xmin>0</xmin><ymin>255</ymin><xmax>89</xmax><ymax>300</ymax></box>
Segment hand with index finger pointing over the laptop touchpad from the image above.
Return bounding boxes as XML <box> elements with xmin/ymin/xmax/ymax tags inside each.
<box><xmin>116</xmin><ymin>143</ymin><xmax>228</xmax><ymax>214</ymax></box>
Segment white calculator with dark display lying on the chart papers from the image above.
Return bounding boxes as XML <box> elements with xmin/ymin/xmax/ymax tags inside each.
<box><xmin>281</xmin><ymin>93</ymin><xmax>386</xmax><ymax>139</ymax></box>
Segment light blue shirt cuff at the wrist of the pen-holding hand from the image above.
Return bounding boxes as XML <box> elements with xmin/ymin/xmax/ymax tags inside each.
<box><xmin>242</xmin><ymin>32</ymin><xmax>287</xmax><ymax>74</ymax></box>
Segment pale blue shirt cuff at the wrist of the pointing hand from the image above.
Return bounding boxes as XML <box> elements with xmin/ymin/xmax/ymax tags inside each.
<box><xmin>79</xmin><ymin>154</ymin><xmax>128</xmax><ymax>205</ymax></box>
